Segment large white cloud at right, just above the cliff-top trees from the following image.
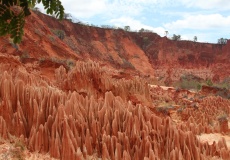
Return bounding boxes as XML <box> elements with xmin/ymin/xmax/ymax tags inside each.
<box><xmin>163</xmin><ymin>14</ymin><xmax>230</xmax><ymax>43</ymax></box>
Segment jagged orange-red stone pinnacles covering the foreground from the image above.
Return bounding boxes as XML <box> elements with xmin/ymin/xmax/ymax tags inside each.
<box><xmin>0</xmin><ymin>62</ymin><xmax>230</xmax><ymax>159</ymax></box>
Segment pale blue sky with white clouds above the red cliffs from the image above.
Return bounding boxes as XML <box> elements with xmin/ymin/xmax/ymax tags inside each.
<box><xmin>38</xmin><ymin>0</ymin><xmax>230</xmax><ymax>43</ymax></box>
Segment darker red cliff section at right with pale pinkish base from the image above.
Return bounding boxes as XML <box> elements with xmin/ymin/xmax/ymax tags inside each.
<box><xmin>132</xmin><ymin>33</ymin><xmax>230</xmax><ymax>81</ymax></box>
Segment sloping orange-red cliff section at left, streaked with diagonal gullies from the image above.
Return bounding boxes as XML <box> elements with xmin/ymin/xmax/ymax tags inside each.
<box><xmin>26</xmin><ymin>11</ymin><xmax>154</xmax><ymax>75</ymax></box>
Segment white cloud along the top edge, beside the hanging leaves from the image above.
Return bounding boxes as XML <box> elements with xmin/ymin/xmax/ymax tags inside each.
<box><xmin>61</xmin><ymin>0</ymin><xmax>170</xmax><ymax>18</ymax></box>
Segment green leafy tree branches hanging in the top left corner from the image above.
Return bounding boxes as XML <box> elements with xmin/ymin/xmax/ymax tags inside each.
<box><xmin>0</xmin><ymin>0</ymin><xmax>64</xmax><ymax>44</ymax></box>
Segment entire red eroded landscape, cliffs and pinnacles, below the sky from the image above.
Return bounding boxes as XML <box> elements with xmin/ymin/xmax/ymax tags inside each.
<box><xmin>0</xmin><ymin>10</ymin><xmax>230</xmax><ymax>160</ymax></box>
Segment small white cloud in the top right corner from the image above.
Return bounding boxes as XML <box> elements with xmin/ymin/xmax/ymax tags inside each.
<box><xmin>179</xmin><ymin>0</ymin><xmax>230</xmax><ymax>10</ymax></box>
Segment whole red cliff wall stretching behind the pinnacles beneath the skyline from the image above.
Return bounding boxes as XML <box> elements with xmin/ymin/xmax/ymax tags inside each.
<box><xmin>2</xmin><ymin>10</ymin><xmax>230</xmax><ymax>82</ymax></box>
